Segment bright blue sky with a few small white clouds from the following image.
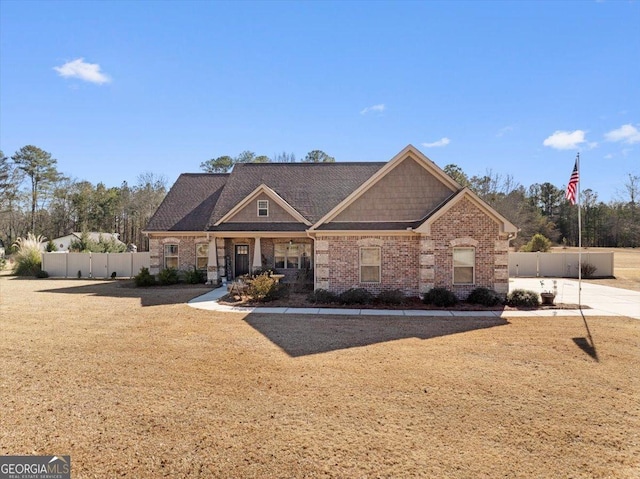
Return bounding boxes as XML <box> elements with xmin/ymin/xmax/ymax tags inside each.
<box><xmin>0</xmin><ymin>0</ymin><xmax>640</xmax><ymax>201</ymax></box>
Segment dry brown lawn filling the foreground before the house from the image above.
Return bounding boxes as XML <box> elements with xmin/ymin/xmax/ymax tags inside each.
<box><xmin>0</xmin><ymin>276</ymin><xmax>640</xmax><ymax>479</ymax></box>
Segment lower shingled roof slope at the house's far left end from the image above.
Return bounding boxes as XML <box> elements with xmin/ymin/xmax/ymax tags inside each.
<box><xmin>146</xmin><ymin>173</ymin><xmax>229</xmax><ymax>231</ymax></box>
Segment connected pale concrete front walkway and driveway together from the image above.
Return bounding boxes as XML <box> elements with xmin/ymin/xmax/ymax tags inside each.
<box><xmin>188</xmin><ymin>278</ymin><xmax>640</xmax><ymax>319</ymax></box>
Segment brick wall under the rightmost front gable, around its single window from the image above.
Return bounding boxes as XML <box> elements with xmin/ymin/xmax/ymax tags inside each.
<box><xmin>421</xmin><ymin>199</ymin><xmax>509</xmax><ymax>299</ymax></box>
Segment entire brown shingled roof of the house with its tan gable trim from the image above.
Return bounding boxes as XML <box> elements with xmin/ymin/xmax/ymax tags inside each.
<box><xmin>145</xmin><ymin>145</ymin><xmax>517</xmax><ymax>233</ymax></box>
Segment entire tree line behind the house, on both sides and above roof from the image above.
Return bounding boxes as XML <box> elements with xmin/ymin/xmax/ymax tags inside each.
<box><xmin>0</xmin><ymin>145</ymin><xmax>640</xmax><ymax>251</ymax></box>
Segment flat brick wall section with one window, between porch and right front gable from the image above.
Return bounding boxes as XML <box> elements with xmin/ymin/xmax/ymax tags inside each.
<box><xmin>315</xmin><ymin>235</ymin><xmax>420</xmax><ymax>296</ymax></box>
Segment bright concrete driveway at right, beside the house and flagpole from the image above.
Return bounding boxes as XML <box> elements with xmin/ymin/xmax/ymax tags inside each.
<box><xmin>509</xmin><ymin>278</ymin><xmax>640</xmax><ymax>319</ymax></box>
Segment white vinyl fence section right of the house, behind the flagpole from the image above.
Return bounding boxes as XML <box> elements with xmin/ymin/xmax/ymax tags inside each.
<box><xmin>509</xmin><ymin>251</ymin><xmax>613</xmax><ymax>278</ymax></box>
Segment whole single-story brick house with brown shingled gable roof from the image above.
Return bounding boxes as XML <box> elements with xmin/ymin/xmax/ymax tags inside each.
<box><xmin>145</xmin><ymin>145</ymin><xmax>517</xmax><ymax>298</ymax></box>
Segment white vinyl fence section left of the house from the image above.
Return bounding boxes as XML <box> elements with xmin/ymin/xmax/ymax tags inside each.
<box><xmin>42</xmin><ymin>252</ymin><xmax>151</xmax><ymax>278</ymax></box>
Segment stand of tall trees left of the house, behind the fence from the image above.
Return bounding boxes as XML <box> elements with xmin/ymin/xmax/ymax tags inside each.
<box><xmin>0</xmin><ymin>145</ymin><xmax>167</xmax><ymax>251</ymax></box>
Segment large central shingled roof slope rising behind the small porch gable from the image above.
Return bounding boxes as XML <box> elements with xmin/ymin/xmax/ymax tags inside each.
<box><xmin>209</xmin><ymin>162</ymin><xmax>386</xmax><ymax>230</ymax></box>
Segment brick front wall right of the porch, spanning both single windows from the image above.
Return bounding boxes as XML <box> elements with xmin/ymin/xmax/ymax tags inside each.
<box><xmin>316</xmin><ymin>199</ymin><xmax>509</xmax><ymax>299</ymax></box>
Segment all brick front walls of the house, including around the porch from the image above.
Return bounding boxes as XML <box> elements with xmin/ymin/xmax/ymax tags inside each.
<box><xmin>149</xmin><ymin>198</ymin><xmax>509</xmax><ymax>299</ymax></box>
